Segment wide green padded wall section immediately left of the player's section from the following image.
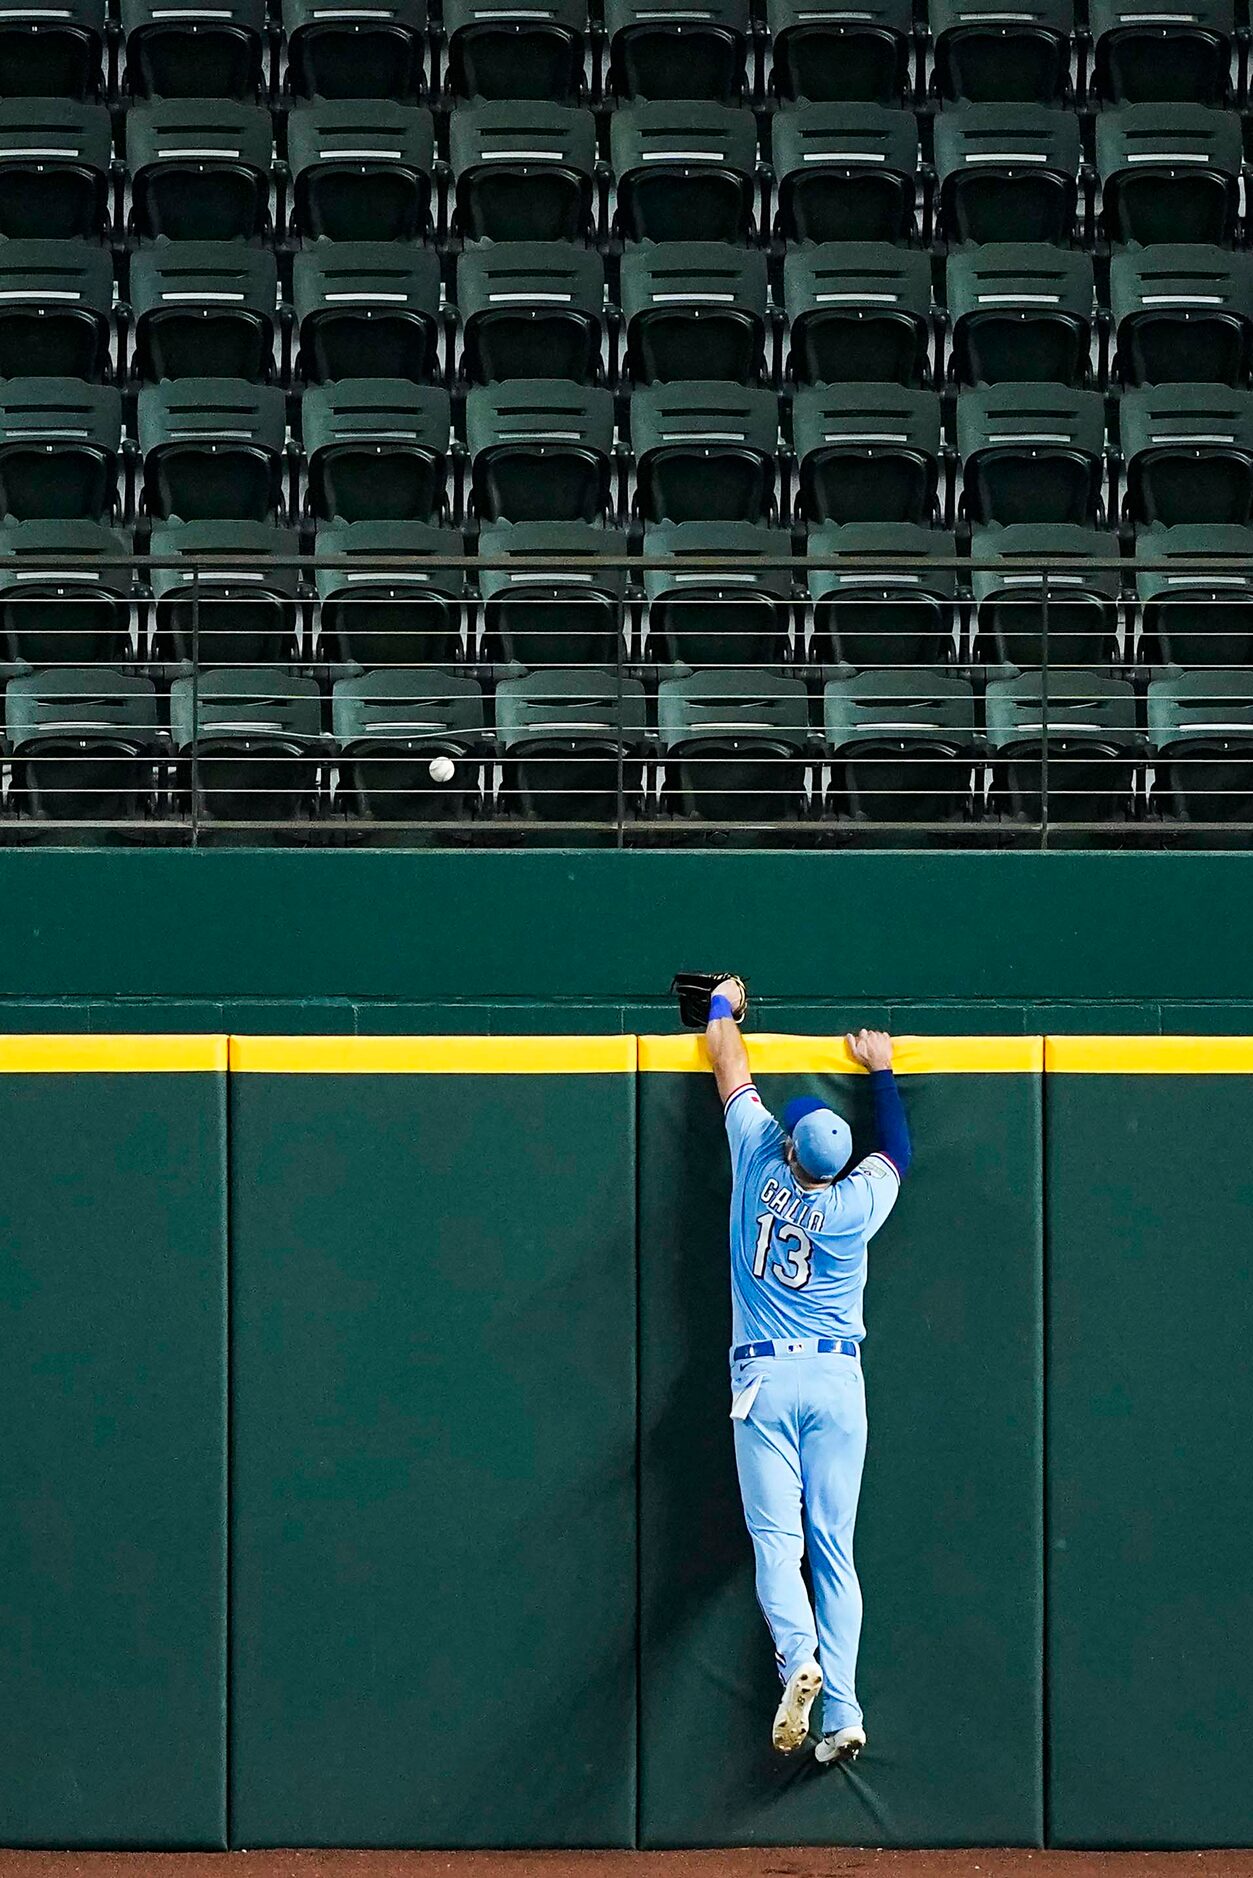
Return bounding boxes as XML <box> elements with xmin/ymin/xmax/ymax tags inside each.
<box><xmin>231</xmin><ymin>1039</ymin><xmax>637</xmax><ymax>1846</ymax></box>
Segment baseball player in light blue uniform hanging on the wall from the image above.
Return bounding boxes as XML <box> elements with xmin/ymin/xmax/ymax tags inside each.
<box><xmin>704</xmin><ymin>978</ymin><xmax>909</xmax><ymax>1765</ymax></box>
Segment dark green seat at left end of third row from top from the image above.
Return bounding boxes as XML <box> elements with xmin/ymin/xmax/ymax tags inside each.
<box><xmin>0</xmin><ymin>240</ymin><xmax>113</xmax><ymax>379</ymax></box>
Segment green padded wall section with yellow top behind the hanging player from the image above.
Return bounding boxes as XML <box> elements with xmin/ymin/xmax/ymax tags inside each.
<box><xmin>639</xmin><ymin>1035</ymin><xmax>1043</xmax><ymax>1846</ymax></box>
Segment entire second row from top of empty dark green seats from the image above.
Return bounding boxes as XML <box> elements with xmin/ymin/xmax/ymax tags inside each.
<box><xmin>0</xmin><ymin>98</ymin><xmax>1244</xmax><ymax>244</ymax></box>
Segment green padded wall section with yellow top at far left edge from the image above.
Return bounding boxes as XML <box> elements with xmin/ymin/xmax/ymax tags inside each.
<box><xmin>0</xmin><ymin>1037</ymin><xmax>225</xmax><ymax>1848</ymax></box>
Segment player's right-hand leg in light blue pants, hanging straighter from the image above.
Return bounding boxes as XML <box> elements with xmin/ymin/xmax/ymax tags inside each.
<box><xmin>800</xmin><ymin>1356</ymin><xmax>866</xmax><ymax>1735</ymax></box>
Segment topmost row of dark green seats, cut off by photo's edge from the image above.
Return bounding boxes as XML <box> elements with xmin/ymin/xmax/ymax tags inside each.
<box><xmin>0</xmin><ymin>0</ymin><xmax>1242</xmax><ymax>103</ymax></box>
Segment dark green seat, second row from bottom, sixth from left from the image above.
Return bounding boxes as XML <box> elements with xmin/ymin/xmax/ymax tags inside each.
<box><xmin>806</xmin><ymin>522</ymin><xmax>958</xmax><ymax>670</ymax></box>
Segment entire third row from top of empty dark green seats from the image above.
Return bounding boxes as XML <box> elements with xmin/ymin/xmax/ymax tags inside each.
<box><xmin>14</xmin><ymin>240</ymin><xmax>1253</xmax><ymax>391</ymax></box>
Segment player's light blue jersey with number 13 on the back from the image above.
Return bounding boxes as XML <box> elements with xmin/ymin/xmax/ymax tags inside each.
<box><xmin>725</xmin><ymin>1082</ymin><xmax>900</xmax><ymax>1345</ymax></box>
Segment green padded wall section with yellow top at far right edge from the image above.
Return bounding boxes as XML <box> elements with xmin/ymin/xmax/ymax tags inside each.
<box><xmin>1046</xmin><ymin>1039</ymin><xmax>1253</xmax><ymax>1846</ymax></box>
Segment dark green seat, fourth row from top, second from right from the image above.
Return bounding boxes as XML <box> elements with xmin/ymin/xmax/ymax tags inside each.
<box><xmin>958</xmin><ymin>381</ymin><xmax>1105</xmax><ymax>522</ymax></box>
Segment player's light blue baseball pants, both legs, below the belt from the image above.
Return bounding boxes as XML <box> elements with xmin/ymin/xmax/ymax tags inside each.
<box><xmin>731</xmin><ymin>1354</ymin><xmax>866</xmax><ymax>1733</ymax></box>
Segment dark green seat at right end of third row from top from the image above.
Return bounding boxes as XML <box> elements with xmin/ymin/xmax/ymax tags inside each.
<box><xmin>1110</xmin><ymin>242</ymin><xmax>1253</xmax><ymax>385</ymax></box>
